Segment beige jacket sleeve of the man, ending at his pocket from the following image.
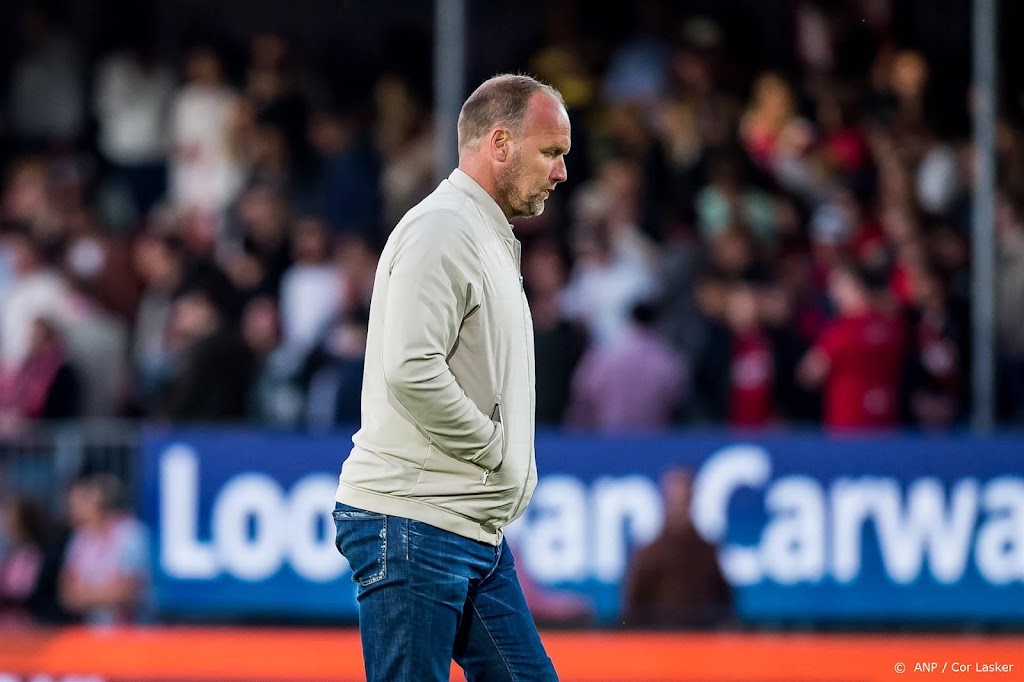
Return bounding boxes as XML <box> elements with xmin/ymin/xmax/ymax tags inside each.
<box><xmin>382</xmin><ymin>211</ymin><xmax>502</xmax><ymax>471</ymax></box>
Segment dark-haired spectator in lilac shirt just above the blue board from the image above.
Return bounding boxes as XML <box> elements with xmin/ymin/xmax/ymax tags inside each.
<box><xmin>567</xmin><ymin>303</ymin><xmax>688</xmax><ymax>433</ymax></box>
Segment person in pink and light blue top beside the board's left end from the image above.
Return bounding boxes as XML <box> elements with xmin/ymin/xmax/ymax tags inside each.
<box><xmin>59</xmin><ymin>474</ymin><xmax>150</xmax><ymax>626</ymax></box>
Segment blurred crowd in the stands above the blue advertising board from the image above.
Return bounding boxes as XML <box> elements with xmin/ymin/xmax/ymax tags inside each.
<box><xmin>0</xmin><ymin>0</ymin><xmax>1024</xmax><ymax>432</ymax></box>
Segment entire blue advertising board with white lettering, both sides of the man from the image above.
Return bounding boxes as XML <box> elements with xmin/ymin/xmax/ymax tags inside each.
<box><xmin>141</xmin><ymin>430</ymin><xmax>1024</xmax><ymax>624</ymax></box>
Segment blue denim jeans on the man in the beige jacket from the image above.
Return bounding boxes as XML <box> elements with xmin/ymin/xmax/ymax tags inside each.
<box><xmin>334</xmin><ymin>503</ymin><xmax>558</xmax><ymax>682</ymax></box>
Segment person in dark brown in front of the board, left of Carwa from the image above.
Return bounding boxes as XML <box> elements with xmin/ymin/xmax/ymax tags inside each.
<box><xmin>623</xmin><ymin>468</ymin><xmax>732</xmax><ymax>628</ymax></box>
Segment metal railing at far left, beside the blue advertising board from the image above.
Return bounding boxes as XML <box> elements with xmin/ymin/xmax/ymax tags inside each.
<box><xmin>0</xmin><ymin>421</ymin><xmax>139</xmax><ymax>514</ymax></box>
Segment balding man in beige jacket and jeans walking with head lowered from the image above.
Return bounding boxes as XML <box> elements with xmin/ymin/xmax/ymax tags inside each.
<box><xmin>334</xmin><ymin>75</ymin><xmax>570</xmax><ymax>682</ymax></box>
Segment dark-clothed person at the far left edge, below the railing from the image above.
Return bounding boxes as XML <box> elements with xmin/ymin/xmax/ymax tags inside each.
<box><xmin>0</xmin><ymin>495</ymin><xmax>59</xmax><ymax>628</ymax></box>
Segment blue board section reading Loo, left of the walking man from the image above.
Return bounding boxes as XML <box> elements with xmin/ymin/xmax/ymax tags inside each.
<box><xmin>140</xmin><ymin>430</ymin><xmax>355</xmax><ymax>619</ymax></box>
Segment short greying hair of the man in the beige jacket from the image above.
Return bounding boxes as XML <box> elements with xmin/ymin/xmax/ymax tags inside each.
<box><xmin>459</xmin><ymin>74</ymin><xmax>565</xmax><ymax>153</ymax></box>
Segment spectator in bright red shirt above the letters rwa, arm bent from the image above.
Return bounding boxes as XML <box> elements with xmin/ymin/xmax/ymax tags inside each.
<box><xmin>798</xmin><ymin>263</ymin><xmax>905</xmax><ymax>430</ymax></box>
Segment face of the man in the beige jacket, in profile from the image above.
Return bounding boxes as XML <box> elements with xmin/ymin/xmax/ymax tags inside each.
<box><xmin>497</xmin><ymin>93</ymin><xmax>570</xmax><ymax>217</ymax></box>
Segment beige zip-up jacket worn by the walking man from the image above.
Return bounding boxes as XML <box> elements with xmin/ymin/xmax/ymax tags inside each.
<box><xmin>336</xmin><ymin>169</ymin><xmax>537</xmax><ymax>545</ymax></box>
